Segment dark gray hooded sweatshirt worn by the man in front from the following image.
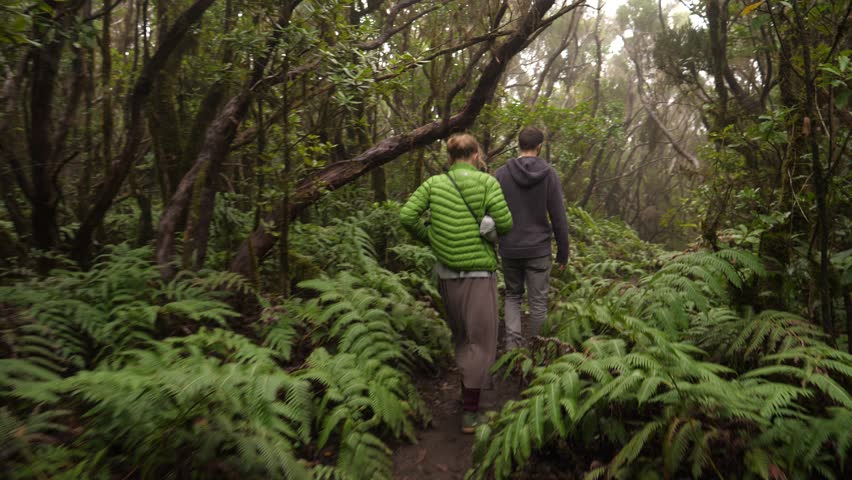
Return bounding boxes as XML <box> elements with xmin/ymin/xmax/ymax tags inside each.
<box><xmin>495</xmin><ymin>157</ymin><xmax>568</xmax><ymax>264</ymax></box>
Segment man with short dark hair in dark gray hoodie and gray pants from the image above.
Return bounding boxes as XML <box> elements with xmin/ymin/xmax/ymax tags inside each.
<box><xmin>495</xmin><ymin>127</ymin><xmax>568</xmax><ymax>350</ymax></box>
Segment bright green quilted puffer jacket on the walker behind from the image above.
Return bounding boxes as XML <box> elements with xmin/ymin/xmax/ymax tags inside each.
<box><xmin>399</xmin><ymin>162</ymin><xmax>512</xmax><ymax>272</ymax></box>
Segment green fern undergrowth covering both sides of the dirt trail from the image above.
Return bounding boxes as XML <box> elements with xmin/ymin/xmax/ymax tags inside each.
<box><xmin>0</xmin><ymin>202</ymin><xmax>852</xmax><ymax>479</ymax></box>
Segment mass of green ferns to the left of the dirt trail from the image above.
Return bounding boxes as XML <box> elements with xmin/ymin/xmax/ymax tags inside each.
<box><xmin>0</xmin><ymin>211</ymin><xmax>452</xmax><ymax>479</ymax></box>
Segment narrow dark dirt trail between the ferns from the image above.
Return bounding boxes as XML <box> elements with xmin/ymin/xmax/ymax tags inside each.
<box><xmin>394</xmin><ymin>371</ymin><xmax>521</xmax><ymax>480</ymax></box>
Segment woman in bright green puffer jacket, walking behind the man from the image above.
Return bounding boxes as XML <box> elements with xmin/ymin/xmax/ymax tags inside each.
<box><xmin>400</xmin><ymin>134</ymin><xmax>512</xmax><ymax>433</ymax></box>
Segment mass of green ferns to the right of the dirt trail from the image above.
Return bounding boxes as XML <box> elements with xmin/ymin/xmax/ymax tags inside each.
<box><xmin>468</xmin><ymin>212</ymin><xmax>852</xmax><ymax>479</ymax></box>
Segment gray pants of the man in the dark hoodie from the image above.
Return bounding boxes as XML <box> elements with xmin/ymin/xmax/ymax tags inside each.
<box><xmin>503</xmin><ymin>255</ymin><xmax>552</xmax><ymax>350</ymax></box>
